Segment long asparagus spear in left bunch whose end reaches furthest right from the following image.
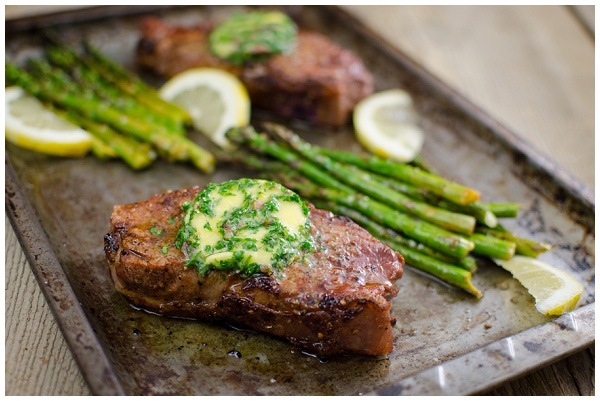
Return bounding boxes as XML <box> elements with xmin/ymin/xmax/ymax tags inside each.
<box><xmin>5</xmin><ymin>63</ymin><xmax>215</xmax><ymax>172</ymax></box>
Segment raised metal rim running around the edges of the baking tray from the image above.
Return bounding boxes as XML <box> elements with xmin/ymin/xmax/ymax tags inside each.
<box><xmin>5</xmin><ymin>6</ymin><xmax>595</xmax><ymax>395</ymax></box>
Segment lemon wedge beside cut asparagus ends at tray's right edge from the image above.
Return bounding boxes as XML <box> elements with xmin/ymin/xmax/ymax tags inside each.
<box><xmin>495</xmin><ymin>256</ymin><xmax>583</xmax><ymax>316</ymax></box>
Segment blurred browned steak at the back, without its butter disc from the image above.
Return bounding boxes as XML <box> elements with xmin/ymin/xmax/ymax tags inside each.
<box><xmin>137</xmin><ymin>17</ymin><xmax>373</xmax><ymax>127</ymax></box>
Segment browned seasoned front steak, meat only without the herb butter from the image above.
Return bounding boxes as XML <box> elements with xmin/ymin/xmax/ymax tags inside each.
<box><xmin>104</xmin><ymin>187</ymin><xmax>404</xmax><ymax>357</ymax></box>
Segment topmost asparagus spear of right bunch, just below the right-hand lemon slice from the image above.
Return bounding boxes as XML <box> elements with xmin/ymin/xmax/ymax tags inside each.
<box><xmin>316</xmin><ymin>148</ymin><xmax>480</xmax><ymax>205</ymax></box>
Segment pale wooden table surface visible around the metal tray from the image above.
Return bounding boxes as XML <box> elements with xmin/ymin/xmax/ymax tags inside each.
<box><xmin>5</xmin><ymin>6</ymin><xmax>595</xmax><ymax>395</ymax></box>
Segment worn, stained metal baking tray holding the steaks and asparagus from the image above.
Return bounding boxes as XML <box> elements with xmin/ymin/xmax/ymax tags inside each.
<box><xmin>5</xmin><ymin>7</ymin><xmax>595</xmax><ymax>395</ymax></box>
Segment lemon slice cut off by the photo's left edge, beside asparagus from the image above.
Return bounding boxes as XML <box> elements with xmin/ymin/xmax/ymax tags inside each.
<box><xmin>4</xmin><ymin>86</ymin><xmax>92</xmax><ymax>157</ymax></box>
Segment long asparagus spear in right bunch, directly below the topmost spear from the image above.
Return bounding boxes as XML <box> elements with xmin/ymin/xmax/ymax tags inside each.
<box><xmin>265</xmin><ymin>124</ymin><xmax>475</xmax><ymax>235</ymax></box>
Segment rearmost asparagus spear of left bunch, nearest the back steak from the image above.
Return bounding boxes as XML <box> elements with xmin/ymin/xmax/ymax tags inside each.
<box><xmin>83</xmin><ymin>40</ymin><xmax>192</xmax><ymax>124</ymax></box>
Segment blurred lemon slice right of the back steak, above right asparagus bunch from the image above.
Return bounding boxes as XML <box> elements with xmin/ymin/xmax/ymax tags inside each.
<box><xmin>353</xmin><ymin>89</ymin><xmax>425</xmax><ymax>163</ymax></box>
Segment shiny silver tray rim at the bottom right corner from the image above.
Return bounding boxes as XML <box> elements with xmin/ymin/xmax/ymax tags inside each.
<box><xmin>372</xmin><ymin>302</ymin><xmax>596</xmax><ymax>396</ymax></box>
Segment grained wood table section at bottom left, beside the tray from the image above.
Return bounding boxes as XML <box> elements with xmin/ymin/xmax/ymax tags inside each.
<box><xmin>4</xmin><ymin>216</ymin><xmax>90</xmax><ymax>396</ymax></box>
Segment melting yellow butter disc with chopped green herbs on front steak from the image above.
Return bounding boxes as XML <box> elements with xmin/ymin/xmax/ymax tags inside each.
<box><xmin>176</xmin><ymin>178</ymin><xmax>315</xmax><ymax>276</ymax></box>
